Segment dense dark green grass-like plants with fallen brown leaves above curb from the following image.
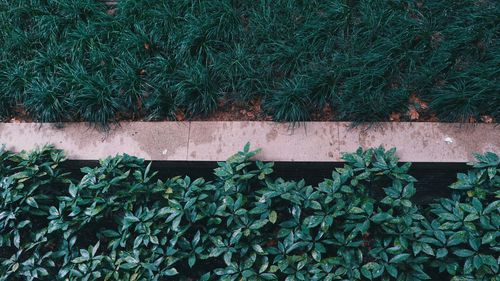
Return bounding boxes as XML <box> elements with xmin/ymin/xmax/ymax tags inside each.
<box><xmin>0</xmin><ymin>0</ymin><xmax>500</xmax><ymax>126</ymax></box>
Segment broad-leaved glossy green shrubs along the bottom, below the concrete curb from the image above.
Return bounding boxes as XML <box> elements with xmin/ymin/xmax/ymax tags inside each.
<box><xmin>0</xmin><ymin>143</ymin><xmax>500</xmax><ymax>281</ymax></box>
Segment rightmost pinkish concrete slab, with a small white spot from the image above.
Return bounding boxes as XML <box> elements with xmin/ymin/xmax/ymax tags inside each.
<box><xmin>339</xmin><ymin>122</ymin><xmax>500</xmax><ymax>162</ymax></box>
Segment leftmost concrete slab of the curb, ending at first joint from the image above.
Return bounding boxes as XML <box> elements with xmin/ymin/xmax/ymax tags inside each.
<box><xmin>0</xmin><ymin>122</ymin><xmax>189</xmax><ymax>160</ymax></box>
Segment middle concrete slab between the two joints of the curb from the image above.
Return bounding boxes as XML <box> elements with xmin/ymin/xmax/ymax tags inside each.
<box><xmin>188</xmin><ymin>122</ymin><xmax>340</xmax><ymax>161</ymax></box>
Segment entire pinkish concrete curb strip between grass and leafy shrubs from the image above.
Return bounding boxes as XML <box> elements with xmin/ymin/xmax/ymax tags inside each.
<box><xmin>0</xmin><ymin>121</ymin><xmax>500</xmax><ymax>163</ymax></box>
